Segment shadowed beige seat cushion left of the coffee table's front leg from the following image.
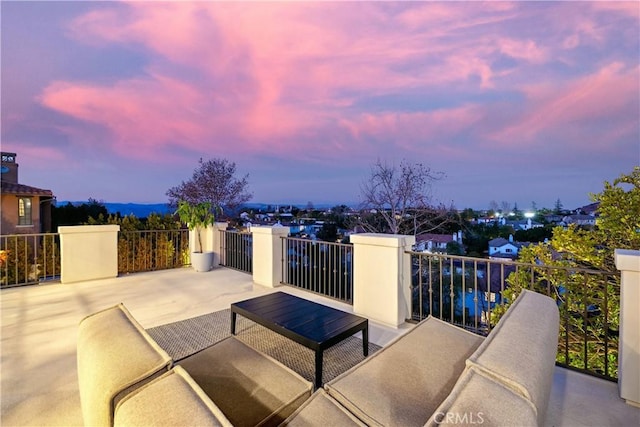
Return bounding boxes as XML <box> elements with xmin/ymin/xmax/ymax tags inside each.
<box><xmin>179</xmin><ymin>337</ymin><xmax>313</xmax><ymax>426</ymax></box>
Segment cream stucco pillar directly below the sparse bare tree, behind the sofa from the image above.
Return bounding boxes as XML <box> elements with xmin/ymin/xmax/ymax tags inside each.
<box><xmin>350</xmin><ymin>233</ymin><xmax>416</xmax><ymax>327</ymax></box>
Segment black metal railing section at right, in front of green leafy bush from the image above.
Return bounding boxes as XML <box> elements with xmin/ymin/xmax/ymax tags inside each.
<box><xmin>410</xmin><ymin>252</ymin><xmax>620</xmax><ymax>380</ymax></box>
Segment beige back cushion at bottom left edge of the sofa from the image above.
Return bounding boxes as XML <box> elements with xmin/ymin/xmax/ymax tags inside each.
<box><xmin>115</xmin><ymin>366</ymin><xmax>232</xmax><ymax>427</ymax></box>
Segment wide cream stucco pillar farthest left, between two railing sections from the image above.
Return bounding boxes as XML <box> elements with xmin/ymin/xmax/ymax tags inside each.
<box><xmin>58</xmin><ymin>225</ymin><xmax>120</xmax><ymax>283</ymax></box>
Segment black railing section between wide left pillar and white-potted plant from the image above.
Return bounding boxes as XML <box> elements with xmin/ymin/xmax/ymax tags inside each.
<box><xmin>118</xmin><ymin>230</ymin><xmax>191</xmax><ymax>274</ymax></box>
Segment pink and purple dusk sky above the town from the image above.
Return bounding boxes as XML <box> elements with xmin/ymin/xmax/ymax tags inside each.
<box><xmin>0</xmin><ymin>1</ymin><xmax>640</xmax><ymax>210</ymax></box>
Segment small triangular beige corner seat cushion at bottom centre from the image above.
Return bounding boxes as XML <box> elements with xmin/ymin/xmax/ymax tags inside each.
<box><xmin>281</xmin><ymin>389</ymin><xmax>366</xmax><ymax>427</ymax></box>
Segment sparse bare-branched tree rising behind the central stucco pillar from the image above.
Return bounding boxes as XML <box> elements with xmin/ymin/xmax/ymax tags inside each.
<box><xmin>360</xmin><ymin>160</ymin><xmax>448</xmax><ymax>234</ymax></box>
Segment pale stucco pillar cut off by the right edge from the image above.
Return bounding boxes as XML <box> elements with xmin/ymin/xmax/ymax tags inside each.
<box><xmin>615</xmin><ymin>249</ymin><xmax>640</xmax><ymax>407</ymax></box>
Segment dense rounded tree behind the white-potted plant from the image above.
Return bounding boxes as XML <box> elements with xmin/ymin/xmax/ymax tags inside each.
<box><xmin>166</xmin><ymin>159</ymin><xmax>252</xmax><ymax>209</ymax></box>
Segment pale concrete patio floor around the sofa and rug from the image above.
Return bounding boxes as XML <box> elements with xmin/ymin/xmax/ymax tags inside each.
<box><xmin>0</xmin><ymin>268</ymin><xmax>640</xmax><ymax>426</ymax></box>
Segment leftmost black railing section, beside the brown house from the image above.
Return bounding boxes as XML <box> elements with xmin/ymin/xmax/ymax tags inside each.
<box><xmin>0</xmin><ymin>233</ymin><xmax>60</xmax><ymax>288</ymax></box>
